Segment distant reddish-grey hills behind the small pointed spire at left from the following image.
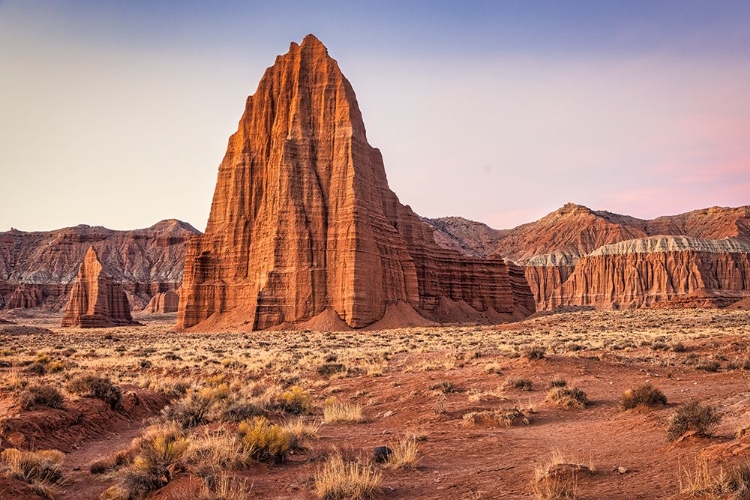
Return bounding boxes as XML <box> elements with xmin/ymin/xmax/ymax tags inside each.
<box><xmin>0</xmin><ymin>219</ymin><xmax>200</xmax><ymax>309</ymax></box>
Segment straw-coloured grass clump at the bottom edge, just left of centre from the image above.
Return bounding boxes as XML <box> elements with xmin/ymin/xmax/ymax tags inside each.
<box><xmin>314</xmin><ymin>453</ymin><xmax>382</xmax><ymax>500</ymax></box>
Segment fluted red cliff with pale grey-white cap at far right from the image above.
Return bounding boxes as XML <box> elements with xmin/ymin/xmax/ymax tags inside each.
<box><xmin>543</xmin><ymin>237</ymin><xmax>750</xmax><ymax>308</ymax></box>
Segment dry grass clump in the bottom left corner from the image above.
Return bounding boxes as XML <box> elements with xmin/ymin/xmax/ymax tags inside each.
<box><xmin>0</xmin><ymin>448</ymin><xmax>65</xmax><ymax>499</ymax></box>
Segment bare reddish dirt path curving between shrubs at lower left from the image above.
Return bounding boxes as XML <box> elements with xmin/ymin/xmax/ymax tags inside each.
<box><xmin>56</xmin><ymin>422</ymin><xmax>145</xmax><ymax>500</ymax></box>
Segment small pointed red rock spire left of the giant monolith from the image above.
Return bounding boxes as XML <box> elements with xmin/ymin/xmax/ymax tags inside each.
<box><xmin>61</xmin><ymin>246</ymin><xmax>138</xmax><ymax>328</ymax></box>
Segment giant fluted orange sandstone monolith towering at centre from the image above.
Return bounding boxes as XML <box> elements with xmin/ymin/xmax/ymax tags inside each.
<box><xmin>178</xmin><ymin>35</ymin><xmax>534</xmax><ymax>330</ymax></box>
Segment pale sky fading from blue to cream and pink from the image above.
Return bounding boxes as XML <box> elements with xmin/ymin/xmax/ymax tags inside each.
<box><xmin>0</xmin><ymin>0</ymin><xmax>750</xmax><ymax>230</ymax></box>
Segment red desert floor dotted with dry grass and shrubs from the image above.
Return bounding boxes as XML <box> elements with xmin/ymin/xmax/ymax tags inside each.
<box><xmin>0</xmin><ymin>310</ymin><xmax>750</xmax><ymax>500</ymax></box>
